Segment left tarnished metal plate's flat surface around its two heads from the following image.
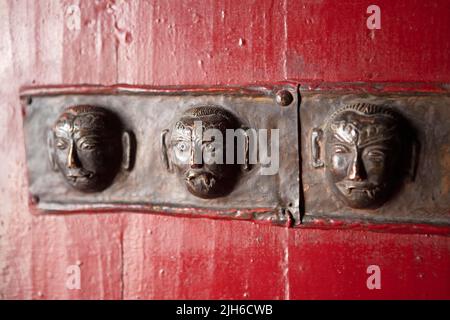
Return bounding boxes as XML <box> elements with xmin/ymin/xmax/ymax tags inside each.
<box><xmin>21</xmin><ymin>84</ymin><xmax>299</xmax><ymax>224</ymax></box>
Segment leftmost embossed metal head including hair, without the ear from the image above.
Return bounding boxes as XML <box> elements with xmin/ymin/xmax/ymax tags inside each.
<box><xmin>52</xmin><ymin>105</ymin><xmax>122</xmax><ymax>192</ymax></box>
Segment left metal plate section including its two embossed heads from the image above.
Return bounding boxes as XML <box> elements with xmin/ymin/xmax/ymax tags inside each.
<box><xmin>21</xmin><ymin>84</ymin><xmax>300</xmax><ymax>225</ymax></box>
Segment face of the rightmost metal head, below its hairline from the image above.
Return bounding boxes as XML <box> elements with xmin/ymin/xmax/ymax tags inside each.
<box><xmin>326</xmin><ymin>112</ymin><xmax>398</xmax><ymax>208</ymax></box>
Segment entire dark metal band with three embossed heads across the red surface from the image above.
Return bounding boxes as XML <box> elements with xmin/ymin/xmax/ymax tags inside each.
<box><xmin>22</xmin><ymin>84</ymin><xmax>450</xmax><ymax>232</ymax></box>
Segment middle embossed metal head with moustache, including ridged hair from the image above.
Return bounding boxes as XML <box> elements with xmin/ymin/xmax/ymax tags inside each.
<box><xmin>170</xmin><ymin>106</ymin><xmax>239</xmax><ymax>199</ymax></box>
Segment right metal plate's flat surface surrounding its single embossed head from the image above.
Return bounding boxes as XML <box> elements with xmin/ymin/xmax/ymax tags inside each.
<box><xmin>300</xmin><ymin>89</ymin><xmax>450</xmax><ymax>225</ymax></box>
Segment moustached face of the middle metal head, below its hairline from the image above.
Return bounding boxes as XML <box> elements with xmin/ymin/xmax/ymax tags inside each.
<box><xmin>170</xmin><ymin>119</ymin><xmax>236</xmax><ymax>199</ymax></box>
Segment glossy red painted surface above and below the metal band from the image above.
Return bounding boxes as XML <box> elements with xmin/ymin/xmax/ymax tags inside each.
<box><xmin>0</xmin><ymin>0</ymin><xmax>450</xmax><ymax>299</ymax></box>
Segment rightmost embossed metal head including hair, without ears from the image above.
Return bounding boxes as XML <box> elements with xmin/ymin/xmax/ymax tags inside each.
<box><xmin>325</xmin><ymin>104</ymin><xmax>401</xmax><ymax>208</ymax></box>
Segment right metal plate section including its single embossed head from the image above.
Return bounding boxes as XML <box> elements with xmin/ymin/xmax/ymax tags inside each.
<box><xmin>300</xmin><ymin>87</ymin><xmax>450</xmax><ymax>226</ymax></box>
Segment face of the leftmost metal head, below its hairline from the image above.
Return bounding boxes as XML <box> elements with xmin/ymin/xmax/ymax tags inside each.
<box><xmin>53</xmin><ymin>114</ymin><xmax>121</xmax><ymax>192</ymax></box>
